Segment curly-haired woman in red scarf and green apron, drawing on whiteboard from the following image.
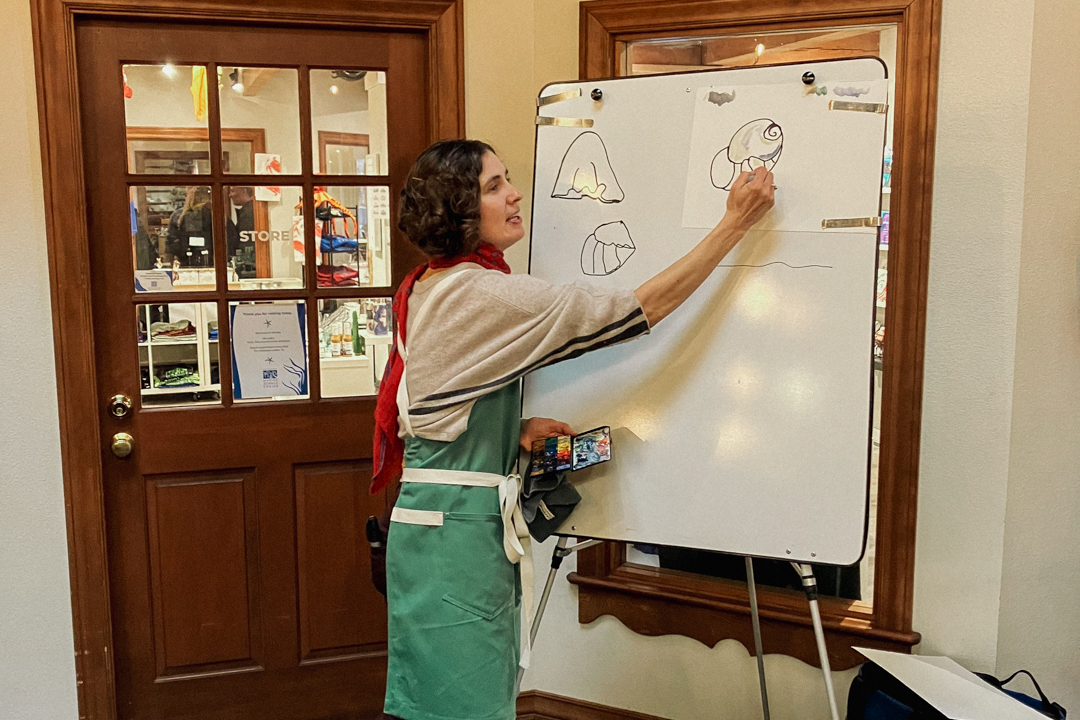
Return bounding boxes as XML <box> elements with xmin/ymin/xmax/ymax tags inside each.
<box><xmin>372</xmin><ymin>140</ymin><xmax>775</xmax><ymax>720</ymax></box>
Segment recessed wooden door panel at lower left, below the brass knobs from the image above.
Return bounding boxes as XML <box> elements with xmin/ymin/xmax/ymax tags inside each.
<box><xmin>147</xmin><ymin>471</ymin><xmax>261</xmax><ymax>678</ymax></box>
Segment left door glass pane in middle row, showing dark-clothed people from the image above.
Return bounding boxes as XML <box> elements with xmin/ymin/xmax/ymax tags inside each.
<box><xmin>129</xmin><ymin>185</ymin><xmax>216</xmax><ymax>293</ymax></box>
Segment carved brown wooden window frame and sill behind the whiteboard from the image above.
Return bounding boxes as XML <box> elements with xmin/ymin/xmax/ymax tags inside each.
<box><xmin>570</xmin><ymin>0</ymin><xmax>942</xmax><ymax>669</ymax></box>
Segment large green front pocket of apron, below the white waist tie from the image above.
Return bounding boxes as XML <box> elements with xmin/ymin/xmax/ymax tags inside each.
<box><xmin>440</xmin><ymin>513</ymin><xmax>517</xmax><ymax>621</ymax></box>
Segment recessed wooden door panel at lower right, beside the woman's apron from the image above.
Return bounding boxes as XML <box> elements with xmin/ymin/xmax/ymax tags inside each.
<box><xmin>296</xmin><ymin>462</ymin><xmax>387</xmax><ymax>662</ymax></box>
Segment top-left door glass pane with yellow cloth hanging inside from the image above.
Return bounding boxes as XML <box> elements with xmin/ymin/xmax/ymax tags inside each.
<box><xmin>123</xmin><ymin>63</ymin><xmax>210</xmax><ymax>175</ymax></box>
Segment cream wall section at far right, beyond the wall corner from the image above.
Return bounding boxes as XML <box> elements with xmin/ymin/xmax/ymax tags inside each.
<box><xmin>997</xmin><ymin>0</ymin><xmax>1080</xmax><ymax>714</ymax></box>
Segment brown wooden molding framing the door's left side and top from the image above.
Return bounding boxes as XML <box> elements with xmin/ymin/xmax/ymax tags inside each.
<box><xmin>30</xmin><ymin>0</ymin><xmax>464</xmax><ymax>720</ymax></box>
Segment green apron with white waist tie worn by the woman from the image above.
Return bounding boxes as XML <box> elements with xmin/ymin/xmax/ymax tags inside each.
<box><xmin>383</xmin><ymin>383</ymin><xmax>522</xmax><ymax>720</ymax></box>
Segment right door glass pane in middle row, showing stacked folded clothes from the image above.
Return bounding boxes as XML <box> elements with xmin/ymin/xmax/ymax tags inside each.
<box><xmin>315</xmin><ymin>186</ymin><xmax>390</xmax><ymax>287</ymax></box>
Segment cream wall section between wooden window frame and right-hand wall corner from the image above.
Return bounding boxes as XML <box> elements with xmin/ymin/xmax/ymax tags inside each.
<box><xmin>914</xmin><ymin>0</ymin><xmax>1035</xmax><ymax>670</ymax></box>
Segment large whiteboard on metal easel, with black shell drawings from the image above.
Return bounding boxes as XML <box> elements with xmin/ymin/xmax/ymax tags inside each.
<box><xmin>523</xmin><ymin>58</ymin><xmax>888</xmax><ymax>565</ymax></box>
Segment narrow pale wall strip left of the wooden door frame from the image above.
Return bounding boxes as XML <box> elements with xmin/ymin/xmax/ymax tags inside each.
<box><xmin>0</xmin><ymin>2</ymin><xmax>78</xmax><ymax>720</ymax></box>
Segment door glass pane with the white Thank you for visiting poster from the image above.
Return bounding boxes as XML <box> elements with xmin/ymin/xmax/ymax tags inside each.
<box><xmin>229</xmin><ymin>300</ymin><xmax>309</xmax><ymax>403</ymax></box>
